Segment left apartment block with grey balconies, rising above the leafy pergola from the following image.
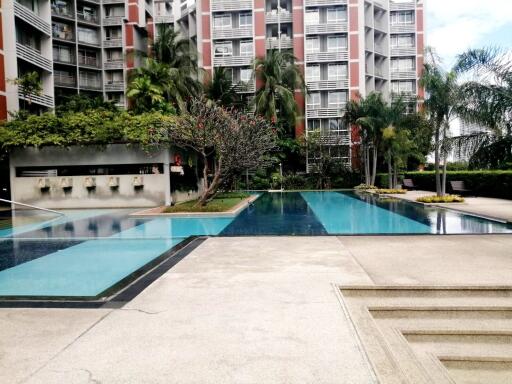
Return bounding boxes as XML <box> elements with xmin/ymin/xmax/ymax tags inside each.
<box><xmin>0</xmin><ymin>0</ymin><xmax>154</xmax><ymax>115</ymax></box>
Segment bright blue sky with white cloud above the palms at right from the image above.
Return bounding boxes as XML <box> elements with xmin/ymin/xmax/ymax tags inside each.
<box><xmin>424</xmin><ymin>0</ymin><xmax>512</xmax><ymax>67</ymax></box>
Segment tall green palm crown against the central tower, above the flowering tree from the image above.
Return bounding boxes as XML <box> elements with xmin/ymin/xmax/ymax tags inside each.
<box><xmin>253</xmin><ymin>50</ymin><xmax>306</xmax><ymax>133</ymax></box>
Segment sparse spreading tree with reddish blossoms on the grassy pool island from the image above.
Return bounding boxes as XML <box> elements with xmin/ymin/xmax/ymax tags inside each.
<box><xmin>169</xmin><ymin>99</ymin><xmax>276</xmax><ymax>206</ymax></box>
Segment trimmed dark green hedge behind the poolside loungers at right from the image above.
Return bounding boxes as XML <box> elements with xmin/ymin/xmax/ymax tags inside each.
<box><xmin>376</xmin><ymin>170</ymin><xmax>512</xmax><ymax>199</ymax></box>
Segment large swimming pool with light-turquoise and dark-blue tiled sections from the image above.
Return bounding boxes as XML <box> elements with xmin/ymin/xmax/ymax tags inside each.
<box><xmin>0</xmin><ymin>192</ymin><xmax>512</xmax><ymax>299</ymax></box>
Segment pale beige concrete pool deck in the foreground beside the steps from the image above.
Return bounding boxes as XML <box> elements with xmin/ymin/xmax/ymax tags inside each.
<box><xmin>0</xmin><ymin>235</ymin><xmax>512</xmax><ymax>384</ymax></box>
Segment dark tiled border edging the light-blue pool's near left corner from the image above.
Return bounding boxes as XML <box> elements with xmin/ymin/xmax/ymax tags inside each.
<box><xmin>0</xmin><ymin>236</ymin><xmax>207</xmax><ymax>309</ymax></box>
